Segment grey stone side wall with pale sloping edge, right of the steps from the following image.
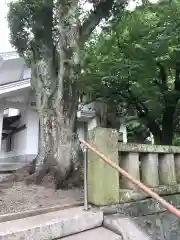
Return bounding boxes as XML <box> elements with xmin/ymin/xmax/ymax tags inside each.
<box><xmin>104</xmin><ymin>212</ymin><xmax>180</xmax><ymax>240</ymax></box>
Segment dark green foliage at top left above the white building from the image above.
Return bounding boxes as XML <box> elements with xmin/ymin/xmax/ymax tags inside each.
<box><xmin>8</xmin><ymin>0</ymin><xmax>56</xmax><ymax>62</ymax></box>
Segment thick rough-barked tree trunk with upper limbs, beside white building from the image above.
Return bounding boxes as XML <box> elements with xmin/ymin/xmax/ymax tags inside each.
<box><xmin>28</xmin><ymin>0</ymin><xmax>114</xmax><ymax>188</ymax></box>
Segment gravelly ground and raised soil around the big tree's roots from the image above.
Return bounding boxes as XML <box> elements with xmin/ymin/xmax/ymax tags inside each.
<box><xmin>0</xmin><ymin>168</ymin><xmax>83</xmax><ymax>214</ymax></box>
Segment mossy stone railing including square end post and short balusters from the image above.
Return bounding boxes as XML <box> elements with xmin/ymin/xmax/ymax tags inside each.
<box><xmin>88</xmin><ymin>128</ymin><xmax>180</xmax><ymax>205</ymax></box>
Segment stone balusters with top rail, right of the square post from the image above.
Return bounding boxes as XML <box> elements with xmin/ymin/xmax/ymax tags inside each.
<box><xmin>118</xmin><ymin>143</ymin><xmax>180</xmax><ymax>189</ymax></box>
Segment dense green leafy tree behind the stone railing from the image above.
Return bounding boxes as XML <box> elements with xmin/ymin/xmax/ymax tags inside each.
<box><xmin>82</xmin><ymin>1</ymin><xmax>180</xmax><ymax>144</ymax></box>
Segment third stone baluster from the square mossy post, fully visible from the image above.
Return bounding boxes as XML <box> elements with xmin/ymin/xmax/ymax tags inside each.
<box><xmin>159</xmin><ymin>153</ymin><xmax>176</xmax><ymax>185</ymax></box>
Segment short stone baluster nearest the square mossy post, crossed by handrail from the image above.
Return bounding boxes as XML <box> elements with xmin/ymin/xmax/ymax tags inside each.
<box><xmin>120</xmin><ymin>153</ymin><xmax>140</xmax><ymax>189</ymax></box>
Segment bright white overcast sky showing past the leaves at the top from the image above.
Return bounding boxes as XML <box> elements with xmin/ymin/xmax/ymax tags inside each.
<box><xmin>0</xmin><ymin>0</ymin><xmax>144</xmax><ymax>52</ymax></box>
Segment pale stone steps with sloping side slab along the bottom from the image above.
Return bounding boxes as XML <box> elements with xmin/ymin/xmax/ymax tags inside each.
<box><xmin>0</xmin><ymin>202</ymin><xmax>177</xmax><ymax>240</ymax></box>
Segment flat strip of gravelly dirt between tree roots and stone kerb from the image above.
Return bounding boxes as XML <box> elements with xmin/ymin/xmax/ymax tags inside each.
<box><xmin>0</xmin><ymin>182</ymin><xmax>83</xmax><ymax>214</ymax></box>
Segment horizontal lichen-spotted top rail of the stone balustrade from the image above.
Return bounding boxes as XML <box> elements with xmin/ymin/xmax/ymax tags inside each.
<box><xmin>118</xmin><ymin>143</ymin><xmax>180</xmax><ymax>153</ymax></box>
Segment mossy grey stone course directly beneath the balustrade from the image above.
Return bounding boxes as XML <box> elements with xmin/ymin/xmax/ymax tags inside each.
<box><xmin>101</xmin><ymin>193</ymin><xmax>180</xmax><ymax>217</ymax></box>
